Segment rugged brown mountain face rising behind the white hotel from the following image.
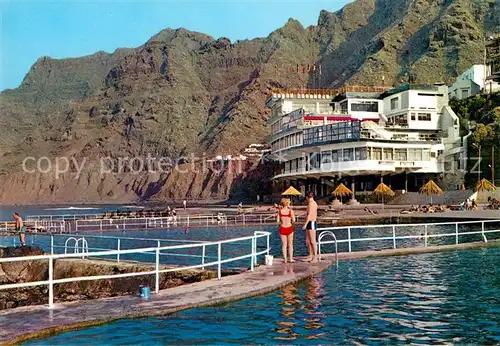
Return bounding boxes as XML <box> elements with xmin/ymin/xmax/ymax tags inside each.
<box><xmin>0</xmin><ymin>0</ymin><xmax>500</xmax><ymax>203</ymax></box>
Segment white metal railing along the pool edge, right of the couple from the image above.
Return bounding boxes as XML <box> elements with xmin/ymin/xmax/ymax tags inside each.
<box><xmin>318</xmin><ymin>220</ymin><xmax>500</xmax><ymax>253</ymax></box>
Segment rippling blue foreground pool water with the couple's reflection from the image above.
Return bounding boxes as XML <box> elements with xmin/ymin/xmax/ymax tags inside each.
<box><xmin>26</xmin><ymin>248</ymin><xmax>500</xmax><ymax>345</ymax></box>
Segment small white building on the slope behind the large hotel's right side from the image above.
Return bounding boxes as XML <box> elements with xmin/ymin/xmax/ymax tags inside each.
<box><xmin>448</xmin><ymin>65</ymin><xmax>500</xmax><ymax>100</ymax></box>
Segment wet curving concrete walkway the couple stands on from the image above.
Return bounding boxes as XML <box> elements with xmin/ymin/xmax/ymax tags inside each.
<box><xmin>0</xmin><ymin>259</ymin><xmax>332</xmax><ymax>344</ymax></box>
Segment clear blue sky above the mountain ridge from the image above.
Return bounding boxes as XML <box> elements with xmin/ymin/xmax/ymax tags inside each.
<box><xmin>0</xmin><ymin>0</ymin><xmax>350</xmax><ymax>90</ymax></box>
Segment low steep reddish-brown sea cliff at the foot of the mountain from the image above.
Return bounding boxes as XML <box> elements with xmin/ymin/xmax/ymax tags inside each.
<box><xmin>0</xmin><ymin>161</ymin><xmax>272</xmax><ymax>205</ymax></box>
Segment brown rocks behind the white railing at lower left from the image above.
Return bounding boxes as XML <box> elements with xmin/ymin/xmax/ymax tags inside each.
<box><xmin>0</xmin><ymin>246</ymin><xmax>217</xmax><ymax>310</ymax></box>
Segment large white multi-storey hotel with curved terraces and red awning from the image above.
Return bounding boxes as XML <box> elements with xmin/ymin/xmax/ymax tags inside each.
<box><xmin>266</xmin><ymin>85</ymin><xmax>465</xmax><ymax>200</ymax></box>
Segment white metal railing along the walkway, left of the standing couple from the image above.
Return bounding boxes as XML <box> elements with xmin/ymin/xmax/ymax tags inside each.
<box><xmin>0</xmin><ymin>231</ymin><xmax>271</xmax><ymax>308</ymax></box>
